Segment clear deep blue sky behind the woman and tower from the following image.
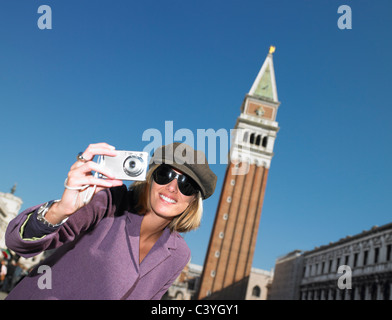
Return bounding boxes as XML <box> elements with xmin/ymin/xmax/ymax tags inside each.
<box><xmin>0</xmin><ymin>0</ymin><xmax>392</xmax><ymax>270</ymax></box>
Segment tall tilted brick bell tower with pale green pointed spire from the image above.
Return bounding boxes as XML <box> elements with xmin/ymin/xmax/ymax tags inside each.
<box><xmin>197</xmin><ymin>46</ymin><xmax>280</xmax><ymax>299</ymax></box>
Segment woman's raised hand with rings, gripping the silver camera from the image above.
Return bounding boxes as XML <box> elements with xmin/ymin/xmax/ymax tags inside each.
<box><xmin>45</xmin><ymin>143</ymin><xmax>123</xmax><ymax>224</ymax></box>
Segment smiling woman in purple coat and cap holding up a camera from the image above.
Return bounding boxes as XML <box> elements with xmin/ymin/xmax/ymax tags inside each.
<box><xmin>6</xmin><ymin>143</ymin><xmax>216</xmax><ymax>299</ymax></box>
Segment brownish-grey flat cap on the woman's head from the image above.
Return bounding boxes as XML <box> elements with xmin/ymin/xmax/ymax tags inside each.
<box><xmin>150</xmin><ymin>142</ymin><xmax>217</xmax><ymax>199</ymax></box>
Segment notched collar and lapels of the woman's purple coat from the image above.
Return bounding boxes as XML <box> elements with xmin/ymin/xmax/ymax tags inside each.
<box><xmin>126</xmin><ymin>212</ymin><xmax>177</xmax><ymax>278</ymax></box>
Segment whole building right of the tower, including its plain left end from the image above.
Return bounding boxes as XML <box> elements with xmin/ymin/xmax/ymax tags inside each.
<box><xmin>270</xmin><ymin>223</ymin><xmax>392</xmax><ymax>300</ymax></box>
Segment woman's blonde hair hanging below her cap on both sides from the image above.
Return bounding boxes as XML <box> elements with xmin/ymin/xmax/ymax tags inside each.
<box><xmin>129</xmin><ymin>167</ymin><xmax>203</xmax><ymax>233</ymax></box>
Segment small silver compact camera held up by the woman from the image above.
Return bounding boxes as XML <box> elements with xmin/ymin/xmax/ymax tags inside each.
<box><xmin>99</xmin><ymin>150</ymin><xmax>148</xmax><ymax>181</ymax></box>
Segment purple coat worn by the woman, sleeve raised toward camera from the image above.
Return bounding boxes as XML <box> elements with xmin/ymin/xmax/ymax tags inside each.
<box><xmin>6</xmin><ymin>186</ymin><xmax>190</xmax><ymax>300</ymax></box>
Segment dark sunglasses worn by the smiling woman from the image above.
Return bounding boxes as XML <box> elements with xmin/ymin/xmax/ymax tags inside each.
<box><xmin>153</xmin><ymin>164</ymin><xmax>200</xmax><ymax>196</ymax></box>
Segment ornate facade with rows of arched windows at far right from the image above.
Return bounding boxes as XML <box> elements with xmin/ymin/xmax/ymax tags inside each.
<box><xmin>299</xmin><ymin>223</ymin><xmax>392</xmax><ymax>300</ymax></box>
